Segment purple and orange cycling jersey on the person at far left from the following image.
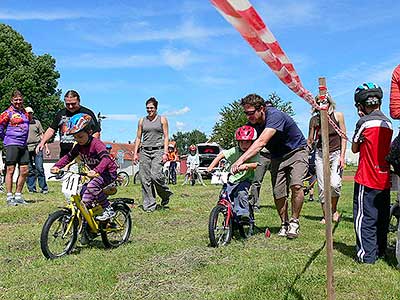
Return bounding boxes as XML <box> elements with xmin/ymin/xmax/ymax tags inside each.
<box><xmin>0</xmin><ymin>105</ymin><xmax>29</xmax><ymax>146</ymax></box>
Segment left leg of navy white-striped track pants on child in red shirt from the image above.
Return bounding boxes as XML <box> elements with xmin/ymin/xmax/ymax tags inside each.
<box><xmin>353</xmin><ymin>183</ymin><xmax>381</xmax><ymax>263</ymax></box>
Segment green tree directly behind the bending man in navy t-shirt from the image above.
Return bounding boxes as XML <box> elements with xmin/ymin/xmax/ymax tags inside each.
<box><xmin>210</xmin><ymin>92</ymin><xmax>294</xmax><ymax>149</ymax></box>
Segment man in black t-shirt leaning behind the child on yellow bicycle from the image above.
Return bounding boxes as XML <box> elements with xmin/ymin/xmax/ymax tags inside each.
<box><xmin>36</xmin><ymin>90</ymin><xmax>101</xmax><ymax>158</ymax></box>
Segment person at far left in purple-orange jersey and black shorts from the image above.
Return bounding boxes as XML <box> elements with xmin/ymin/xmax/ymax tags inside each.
<box><xmin>0</xmin><ymin>90</ymin><xmax>29</xmax><ymax>206</ymax></box>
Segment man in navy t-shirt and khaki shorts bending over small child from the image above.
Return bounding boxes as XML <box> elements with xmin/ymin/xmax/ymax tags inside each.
<box><xmin>231</xmin><ymin>94</ymin><xmax>308</xmax><ymax>238</ymax></box>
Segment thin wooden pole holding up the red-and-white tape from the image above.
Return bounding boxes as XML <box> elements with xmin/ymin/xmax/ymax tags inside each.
<box><xmin>318</xmin><ymin>77</ymin><xmax>335</xmax><ymax>300</ymax></box>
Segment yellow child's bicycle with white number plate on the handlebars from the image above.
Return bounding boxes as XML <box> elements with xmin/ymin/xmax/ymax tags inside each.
<box><xmin>40</xmin><ymin>171</ymin><xmax>133</xmax><ymax>259</ymax></box>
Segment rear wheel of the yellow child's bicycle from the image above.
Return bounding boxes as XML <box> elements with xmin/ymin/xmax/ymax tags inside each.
<box><xmin>101</xmin><ymin>206</ymin><xmax>132</xmax><ymax>248</ymax></box>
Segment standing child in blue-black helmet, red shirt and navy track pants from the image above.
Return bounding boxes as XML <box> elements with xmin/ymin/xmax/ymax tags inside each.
<box><xmin>351</xmin><ymin>82</ymin><xmax>393</xmax><ymax>264</ymax></box>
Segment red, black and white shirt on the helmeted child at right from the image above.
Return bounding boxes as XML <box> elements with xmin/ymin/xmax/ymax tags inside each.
<box><xmin>353</xmin><ymin>110</ymin><xmax>393</xmax><ymax>190</ymax></box>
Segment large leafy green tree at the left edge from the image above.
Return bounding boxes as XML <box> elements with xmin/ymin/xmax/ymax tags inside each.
<box><xmin>0</xmin><ymin>24</ymin><xmax>63</xmax><ymax>129</ymax></box>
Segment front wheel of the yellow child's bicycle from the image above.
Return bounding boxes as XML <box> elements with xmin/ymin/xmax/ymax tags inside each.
<box><xmin>40</xmin><ymin>210</ymin><xmax>79</xmax><ymax>259</ymax></box>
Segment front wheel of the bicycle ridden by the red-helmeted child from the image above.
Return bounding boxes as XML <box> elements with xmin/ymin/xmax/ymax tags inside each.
<box><xmin>208</xmin><ymin>205</ymin><xmax>233</xmax><ymax>247</ymax></box>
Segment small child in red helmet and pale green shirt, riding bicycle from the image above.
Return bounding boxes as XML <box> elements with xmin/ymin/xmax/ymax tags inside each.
<box><xmin>207</xmin><ymin>125</ymin><xmax>259</xmax><ymax>221</ymax></box>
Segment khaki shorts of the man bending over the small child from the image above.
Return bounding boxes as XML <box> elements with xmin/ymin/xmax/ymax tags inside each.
<box><xmin>271</xmin><ymin>148</ymin><xmax>308</xmax><ymax>199</ymax></box>
